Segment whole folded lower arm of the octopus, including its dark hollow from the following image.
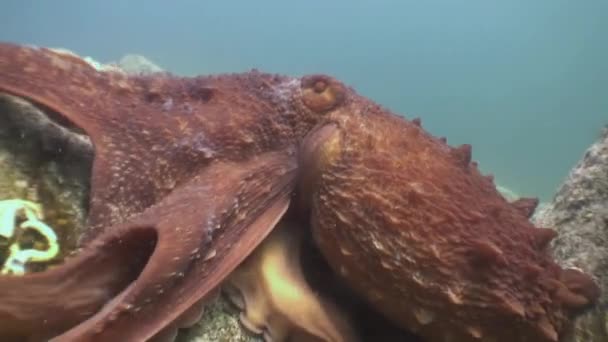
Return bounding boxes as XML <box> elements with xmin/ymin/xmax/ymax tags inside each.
<box><xmin>0</xmin><ymin>152</ymin><xmax>295</xmax><ymax>341</ymax></box>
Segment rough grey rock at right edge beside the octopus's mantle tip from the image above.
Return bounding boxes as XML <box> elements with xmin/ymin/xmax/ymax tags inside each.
<box><xmin>533</xmin><ymin>126</ymin><xmax>608</xmax><ymax>342</ymax></box>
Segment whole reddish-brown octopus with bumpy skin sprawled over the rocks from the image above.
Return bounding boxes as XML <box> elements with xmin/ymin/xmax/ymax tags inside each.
<box><xmin>0</xmin><ymin>43</ymin><xmax>599</xmax><ymax>342</ymax></box>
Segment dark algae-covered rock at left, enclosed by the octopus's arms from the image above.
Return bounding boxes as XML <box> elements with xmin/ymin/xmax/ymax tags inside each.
<box><xmin>0</xmin><ymin>94</ymin><xmax>92</xmax><ymax>271</ymax></box>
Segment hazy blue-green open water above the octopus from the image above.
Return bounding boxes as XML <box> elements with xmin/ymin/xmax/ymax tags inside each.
<box><xmin>0</xmin><ymin>0</ymin><xmax>608</xmax><ymax>201</ymax></box>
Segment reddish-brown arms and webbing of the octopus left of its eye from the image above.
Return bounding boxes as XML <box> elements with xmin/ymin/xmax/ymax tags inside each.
<box><xmin>0</xmin><ymin>44</ymin><xmax>308</xmax><ymax>341</ymax></box>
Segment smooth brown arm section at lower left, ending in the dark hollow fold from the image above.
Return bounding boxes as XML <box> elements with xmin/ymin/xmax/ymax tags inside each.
<box><xmin>0</xmin><ymin>224</ymin><xmax>155</xmax><ymax>341</ymax></box>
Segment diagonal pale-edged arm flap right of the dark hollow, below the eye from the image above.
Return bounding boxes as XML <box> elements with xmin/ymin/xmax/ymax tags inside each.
<box><xmin>53</xmin><ymin>153</ymin><xmax>295</xmax><ymax>341</ymax></box>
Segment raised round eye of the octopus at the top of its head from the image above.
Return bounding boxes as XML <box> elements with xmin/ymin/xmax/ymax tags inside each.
<box><xmin>302</xmin><ymin>75</ymin><xmax>346</xmax><ymax>113</ymax></box>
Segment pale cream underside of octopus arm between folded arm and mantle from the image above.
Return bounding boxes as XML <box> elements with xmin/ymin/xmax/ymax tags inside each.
<box><xmin>225</xmin><ymin>222</ymin><xmax>357</xmax><ymax>342</ymax></box>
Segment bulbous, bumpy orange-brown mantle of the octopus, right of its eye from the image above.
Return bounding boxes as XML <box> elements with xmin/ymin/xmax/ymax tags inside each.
<box><xmin>302</xmin><ymin>76</ymin><xmax>598</xmax><ymax>342</ymax></box>
